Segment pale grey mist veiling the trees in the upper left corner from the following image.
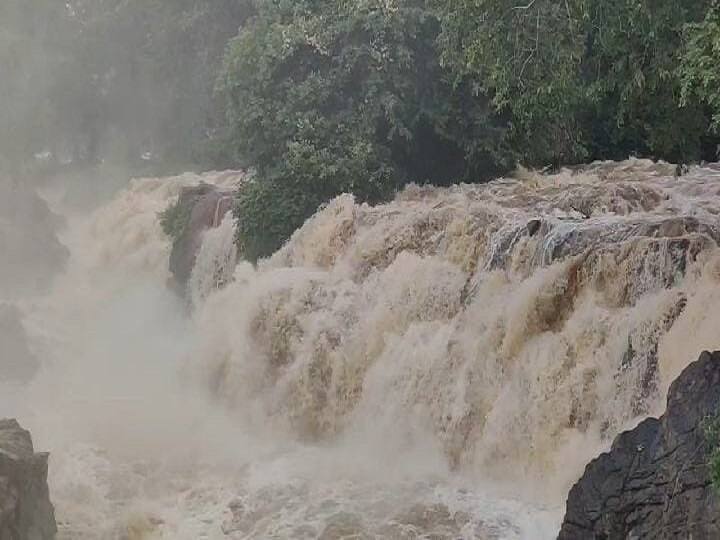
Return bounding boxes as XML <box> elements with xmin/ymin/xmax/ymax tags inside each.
<box><xmin>0</xmin><ymin>0</ymin><xmax>251</xmax><ymax>174</ymax></box>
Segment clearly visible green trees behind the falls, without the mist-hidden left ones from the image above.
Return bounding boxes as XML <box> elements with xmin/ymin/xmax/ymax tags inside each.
<box><xmin>221</xmin><ymin>0</ymin><xmax>720</xmax><ymax>258</ymax></box>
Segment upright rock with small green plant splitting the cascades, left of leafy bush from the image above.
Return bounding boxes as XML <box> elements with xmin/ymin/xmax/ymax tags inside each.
<box><xmin>170</xmin><ymin>183</ymin><xmax>232</xmax><ymax>292</ymax></box>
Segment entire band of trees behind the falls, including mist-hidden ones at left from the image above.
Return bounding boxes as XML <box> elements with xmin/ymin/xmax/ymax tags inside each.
<box><xmin>0</xmin><ymin>0</ymin><xmax>720</xmax><ymax>259</ymax></box>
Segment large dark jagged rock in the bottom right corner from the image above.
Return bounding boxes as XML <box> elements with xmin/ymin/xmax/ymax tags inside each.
<box><xmin>558</xmin><ymin>352</ymin><xmax>720</xmax><ymax>540</ymax></box>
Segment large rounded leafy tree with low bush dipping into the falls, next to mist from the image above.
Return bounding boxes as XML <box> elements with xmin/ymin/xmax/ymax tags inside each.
<box><xmin>220</xmin><ymin>0</ymin><xmax>514</xmax><ymax>260</ymax></box>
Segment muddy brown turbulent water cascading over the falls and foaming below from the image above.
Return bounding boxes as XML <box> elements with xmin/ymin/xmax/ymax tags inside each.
<box><xmin>0</xmin><ymin>160</ymin><xmax>720</xmax><ymax>540</ymax></box>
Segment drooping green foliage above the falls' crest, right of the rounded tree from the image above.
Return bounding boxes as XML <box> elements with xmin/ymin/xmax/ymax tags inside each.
<box><xmin>440</xmin><ymin>0</ymin><xmax>717</xmax><ymax>165</ymax></box>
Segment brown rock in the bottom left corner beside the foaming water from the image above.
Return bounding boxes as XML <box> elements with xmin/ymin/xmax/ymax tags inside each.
<box><xmin>0</xmin><ymin>420</ymin><xmax>57</xmax><ymax>540</ymax></box>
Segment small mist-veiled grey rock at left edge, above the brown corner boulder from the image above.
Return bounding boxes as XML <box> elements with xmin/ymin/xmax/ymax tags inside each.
<box><xmin>0</xmin><ymin>303</ymin><xmax>39</xmax><ymax>382</ymax></box>
